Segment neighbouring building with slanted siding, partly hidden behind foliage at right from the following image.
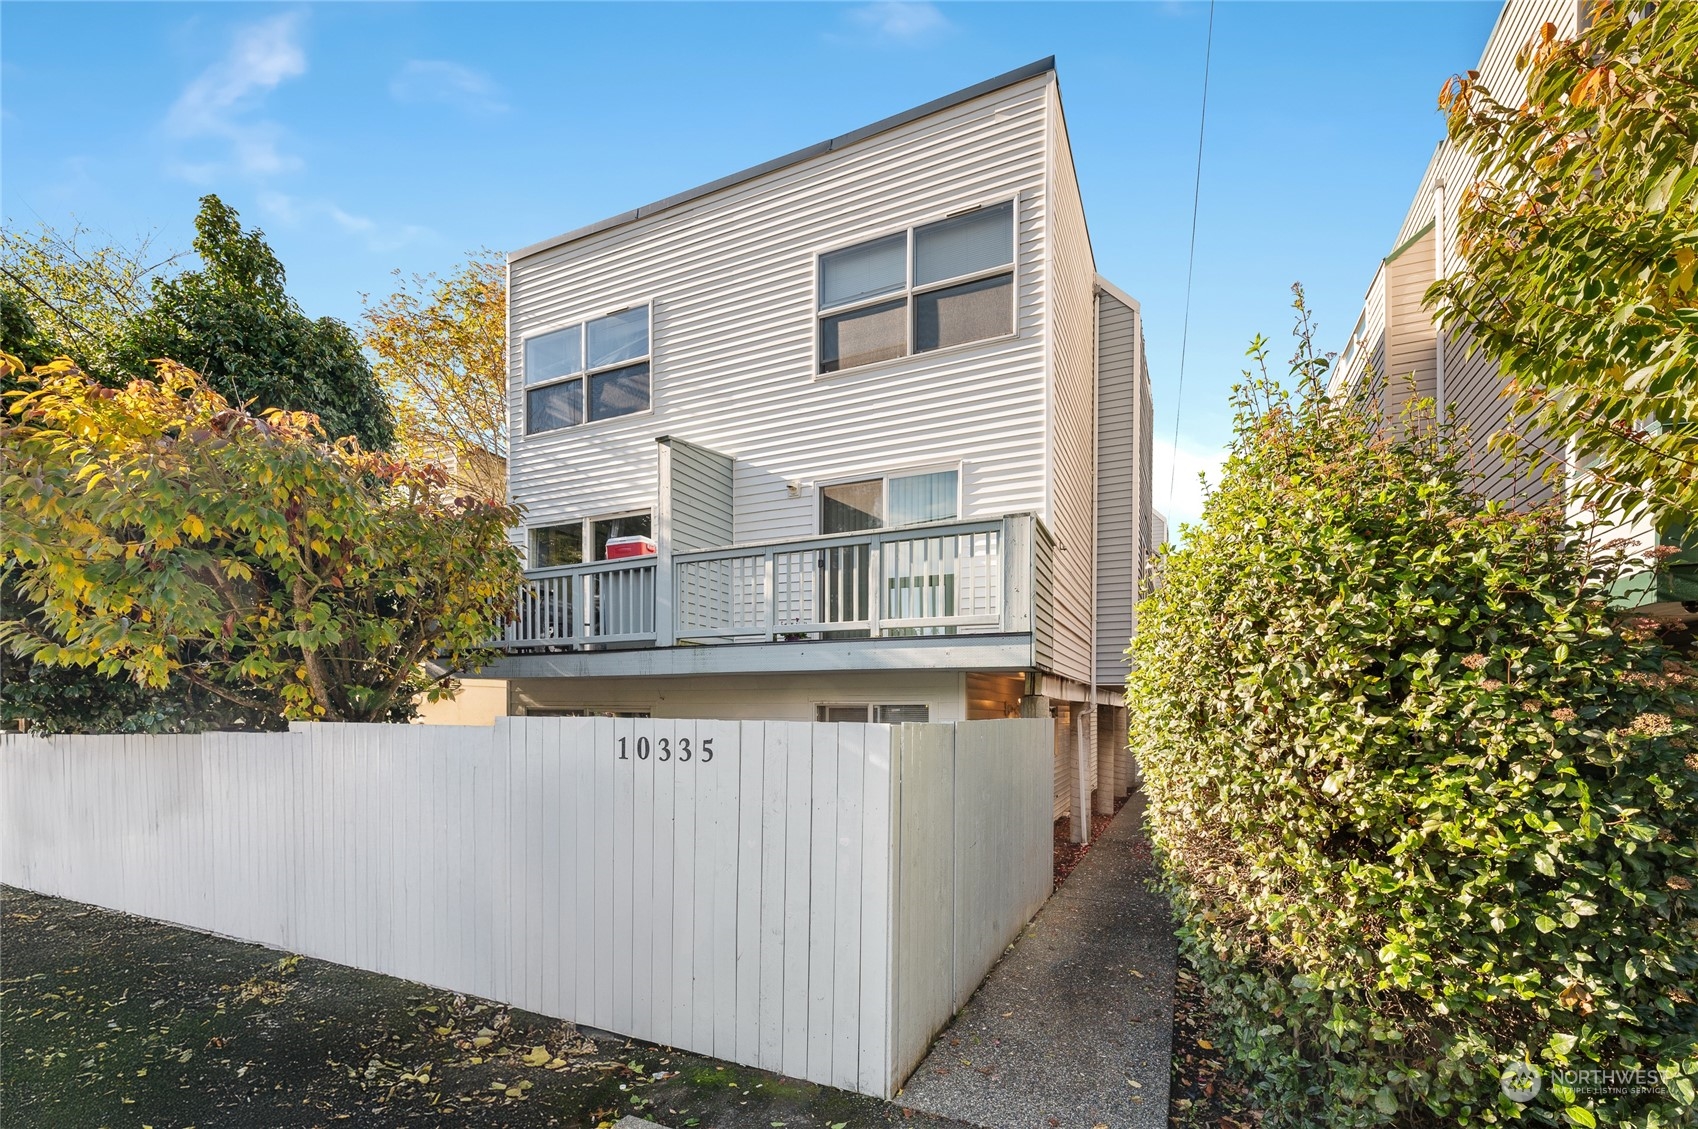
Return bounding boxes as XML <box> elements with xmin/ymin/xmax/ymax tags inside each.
<box><xmin>1331</xmin><ymin>0</ymin><xmax>1698</xmax><ymax>616</ymax></box>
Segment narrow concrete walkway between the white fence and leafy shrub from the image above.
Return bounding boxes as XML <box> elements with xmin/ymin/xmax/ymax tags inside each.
<box><xmin>897</xmin><ymin>795</ymin><xmax>1173</xmax><ymax>1129</ymax></box>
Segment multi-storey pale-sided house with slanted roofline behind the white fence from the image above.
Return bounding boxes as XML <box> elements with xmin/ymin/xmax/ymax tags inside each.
<box><xmin>461</xmin><ymin>59</ymin><xmax>1153</xmax><ymax>837</ymax></box>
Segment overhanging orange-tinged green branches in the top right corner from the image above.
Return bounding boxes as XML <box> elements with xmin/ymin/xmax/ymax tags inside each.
<box><xmin>1430</xmin><ymin>2</ymin><xmax>1698</xmax><ymax>533</ymax></box>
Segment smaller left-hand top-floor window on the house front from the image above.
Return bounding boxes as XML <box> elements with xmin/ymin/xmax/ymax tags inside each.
<box><xmin>525</xmin><ymin>306</ymin><xmax>649</xmax><ymax>435</ymax></box>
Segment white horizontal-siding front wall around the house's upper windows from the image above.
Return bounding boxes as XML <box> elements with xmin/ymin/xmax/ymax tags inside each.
<box><xmin>509</xmin><ymin>73</ymin><xmax>1059</xmax><ymax>542</ymax></box>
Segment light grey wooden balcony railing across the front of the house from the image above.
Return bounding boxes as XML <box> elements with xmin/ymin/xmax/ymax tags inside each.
<box><xmin>498</xmin><ymin>514</ymin><xmax>1034</xmax><ymax>650</ymax></box>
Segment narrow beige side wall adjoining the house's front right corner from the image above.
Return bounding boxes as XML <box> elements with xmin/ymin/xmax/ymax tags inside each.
<box><xmin>1048</xmin><ymin>85</ymin><xmax>1097</xmax><ymax>682</ymax></box>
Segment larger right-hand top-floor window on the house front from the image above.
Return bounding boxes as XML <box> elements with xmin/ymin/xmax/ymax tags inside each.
<box><xmin>818</xmin><ymin>200</ymin><xmax>1014</xmax><ymax>372</ymax></box>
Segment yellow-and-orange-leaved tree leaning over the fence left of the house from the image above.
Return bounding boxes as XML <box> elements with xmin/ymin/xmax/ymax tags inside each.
<box><xmin>0</xmin><ymin>355</ymin><xmax>520</xmax><ymax>722</ymax></box>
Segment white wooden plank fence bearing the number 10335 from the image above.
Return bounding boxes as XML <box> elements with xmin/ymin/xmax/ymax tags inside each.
<box><xmin>0</xmin><ymin>718</ymin><xmax>1053</xmax><ymax>1097</ymax></box>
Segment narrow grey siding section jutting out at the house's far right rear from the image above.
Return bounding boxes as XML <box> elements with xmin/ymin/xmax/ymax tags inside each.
<box><xmin>1094</xmin><ymin>289</ymin><xmax>1150</xmax><ymax>686</ymax></box>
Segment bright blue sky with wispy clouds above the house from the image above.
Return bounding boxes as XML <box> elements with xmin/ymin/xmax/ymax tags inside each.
<box><xmin>0</xmin><ymin>0</ymin><xmax>1499</xmax><ymax>529</ymax></box>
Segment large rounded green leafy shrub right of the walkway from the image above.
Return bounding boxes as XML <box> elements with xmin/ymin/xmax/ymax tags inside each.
<box><xmin>1127</xmin><ymin>317</ymin><xmax>1698</xmax><ymax>1126</ymax></box>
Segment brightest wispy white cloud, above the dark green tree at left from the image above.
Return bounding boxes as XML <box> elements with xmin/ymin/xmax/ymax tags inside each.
<box><xmin>165</xmin><ymin>12</ymin><xmax>307</xmax><ymax>180</ymax></box>
